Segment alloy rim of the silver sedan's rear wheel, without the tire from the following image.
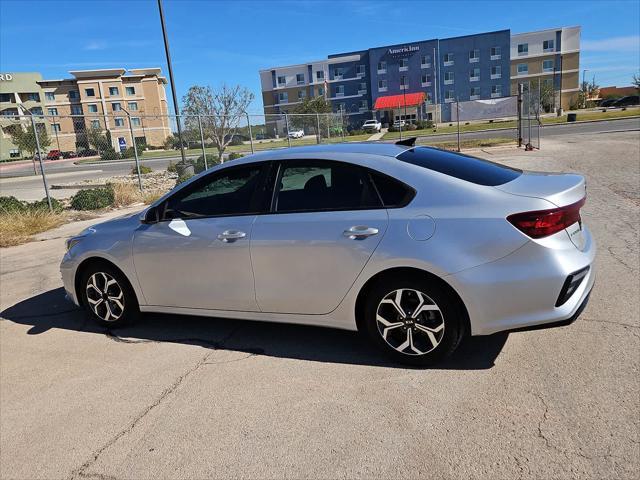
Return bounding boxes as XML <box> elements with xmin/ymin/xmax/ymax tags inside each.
<box><xmin>376</xmin><ymin>288</ymin><xmax>444</xmax><ymax>355</ymax></box>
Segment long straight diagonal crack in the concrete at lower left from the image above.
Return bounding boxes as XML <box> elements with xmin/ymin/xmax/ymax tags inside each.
<box><xmin>69</xmin><ymin>325</ymin><xmax>245</xmax><ymax>480</ymax></box>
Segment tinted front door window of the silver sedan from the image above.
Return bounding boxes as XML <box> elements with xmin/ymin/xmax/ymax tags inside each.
<box><xmin>165</xmin><ymin>165</ymin><xmax>262</xmax><ymax>219</ymax></box>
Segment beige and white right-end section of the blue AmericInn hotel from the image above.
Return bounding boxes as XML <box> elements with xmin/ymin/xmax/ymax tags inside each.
<box><xmin>511</xmin><ymin>27</ymin><xmax>580</xmax><ymax>110</ymax></box>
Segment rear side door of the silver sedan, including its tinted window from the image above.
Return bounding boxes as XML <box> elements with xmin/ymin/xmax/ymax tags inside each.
<box><xmin>251</xmin><ymin>160</ymin><xmax>388</xmax><ymax>314</ymax></box>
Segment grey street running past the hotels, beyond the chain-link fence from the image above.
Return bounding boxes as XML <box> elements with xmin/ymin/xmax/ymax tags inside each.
<box><xmin>0</xmin><ymin>118</ymin><xmax>640</xmax><ymax>200</ymax></box>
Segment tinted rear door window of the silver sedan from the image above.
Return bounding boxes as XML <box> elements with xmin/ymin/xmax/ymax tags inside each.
<box><xmin>275</xmin><ymin>161</ymin><xmax>381</xmax><ymax>212</ymax></box>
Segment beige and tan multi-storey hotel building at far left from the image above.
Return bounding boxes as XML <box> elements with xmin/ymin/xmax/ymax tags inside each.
<box><xmin>0</xmin><ymin>68</ymin><xmax>172</xmax><ymax>159</ymax></box>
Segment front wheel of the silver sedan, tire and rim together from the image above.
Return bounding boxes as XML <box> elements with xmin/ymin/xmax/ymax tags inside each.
<box><xmin>79</xmin><ymin>262</ymin><xmax>140</xmax><ymax>328</ymax></box>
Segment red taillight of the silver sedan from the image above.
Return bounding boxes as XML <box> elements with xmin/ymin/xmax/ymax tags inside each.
<box><xmin>507</xmin><ymin>197</ymin><xmax>586</xmax><ymax>238</ymax></box>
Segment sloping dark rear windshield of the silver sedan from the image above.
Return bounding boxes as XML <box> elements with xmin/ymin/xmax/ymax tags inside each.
<box><xmin>398</xmin><ymin>147</ymin><xmax>522</xmax><ymax>187</ymax></box>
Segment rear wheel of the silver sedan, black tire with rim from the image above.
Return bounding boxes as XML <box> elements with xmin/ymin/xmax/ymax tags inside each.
<box><xmin>362</xmin><ymin>277</ymin><xmax>465</xmax><ymax>367</ymax></box>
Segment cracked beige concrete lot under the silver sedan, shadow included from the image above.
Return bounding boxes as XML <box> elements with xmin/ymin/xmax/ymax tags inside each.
<box><xmin>0</xmin><ymin>132</ymin><xmax>640</xmax><ymax>480</ymax></box>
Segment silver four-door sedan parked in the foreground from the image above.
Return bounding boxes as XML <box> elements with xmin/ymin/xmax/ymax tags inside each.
<box><xmin>61</xmin><ymin>139</ymin><xmax>596</xmax><ymax>365</ymax></box>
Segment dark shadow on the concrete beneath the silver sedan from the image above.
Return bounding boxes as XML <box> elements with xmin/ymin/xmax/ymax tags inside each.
<box><xmin>0</xmin><ymin>288</ymin><xmax>508</xmax><ymax>370</ymax></box>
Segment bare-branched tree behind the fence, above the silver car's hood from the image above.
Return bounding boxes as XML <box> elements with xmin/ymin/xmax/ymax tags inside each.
<box><xmin>182</xmin><ymin>85</ymin><xmax>254</xmax><ymax>162</ymax></box>
